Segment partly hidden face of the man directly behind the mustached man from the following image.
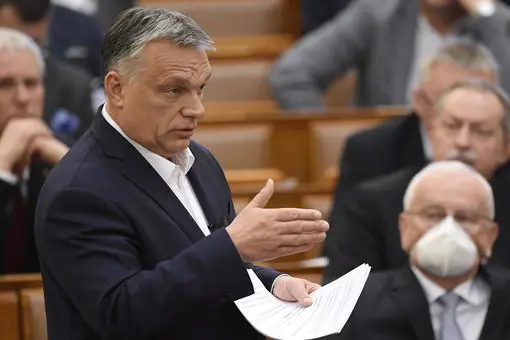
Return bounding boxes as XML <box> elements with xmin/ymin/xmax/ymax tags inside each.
<box><xmin>413</xmin><ymin>61</ymin><xmax>496</xmax><ymax>124</ymax></box>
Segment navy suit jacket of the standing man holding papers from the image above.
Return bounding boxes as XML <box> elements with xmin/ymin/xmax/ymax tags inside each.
<box><xmin>35</xmin><ymin>113</ymin><xmax>279</xmax><ymax>340</ymax></box>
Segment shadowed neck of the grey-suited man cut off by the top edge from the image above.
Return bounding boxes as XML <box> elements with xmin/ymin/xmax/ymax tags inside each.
<box><xmin>420</xmin><ymin>0</ymin><xmax>467</xmax><ymax>35</ymax></box>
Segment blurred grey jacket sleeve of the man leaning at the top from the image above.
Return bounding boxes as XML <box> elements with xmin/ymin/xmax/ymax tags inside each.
<box><xmin>269</xmin><ymin>0</ymin><xmax>375</xmax><ymax>110</ymax></box>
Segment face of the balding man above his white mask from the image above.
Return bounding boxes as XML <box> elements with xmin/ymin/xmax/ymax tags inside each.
<box><xmin>400</xmin><ymin>170</ymin><xmax>498</xmax><ymax>263</ymax></box>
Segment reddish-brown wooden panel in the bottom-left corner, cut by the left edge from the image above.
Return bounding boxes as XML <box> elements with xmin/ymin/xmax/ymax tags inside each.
<box><xmin>0</xmin><ymin>291</ymin><xmax>20</xmax><ymax>340</ymax></box>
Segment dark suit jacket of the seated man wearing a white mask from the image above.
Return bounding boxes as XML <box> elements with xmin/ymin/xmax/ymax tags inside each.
<box><xmin>327</xmin><ymin>264</ymin><xmax>510</xmax><ymax>340</ymax></box>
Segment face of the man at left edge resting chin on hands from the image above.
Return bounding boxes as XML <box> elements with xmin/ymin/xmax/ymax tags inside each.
<box><xmin>0</xmin><ymin>51</ymin><xmax>44</xmax><ymax>133</ymax></box>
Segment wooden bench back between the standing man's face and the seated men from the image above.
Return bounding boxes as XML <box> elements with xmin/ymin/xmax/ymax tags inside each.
<box><xmin>194</xmin><ymin>107</ymin><xmax>407</xmax><ymax>183</ymax></box>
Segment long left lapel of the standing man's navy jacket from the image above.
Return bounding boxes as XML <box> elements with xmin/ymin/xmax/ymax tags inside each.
<box><xmin>92</xmin><ymin>113</ymin><xmax>204</xmax><ymax>243</ymax></box>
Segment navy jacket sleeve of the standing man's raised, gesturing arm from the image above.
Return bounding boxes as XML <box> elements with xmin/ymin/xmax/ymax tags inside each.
<box><xmin>36</xmin><ymin>188</ymin><xmax>253</xmax><ymax>340</ymax></box>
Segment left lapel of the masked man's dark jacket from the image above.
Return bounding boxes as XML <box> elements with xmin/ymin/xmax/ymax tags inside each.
<box><xmin>390</xmin><ymin>265</ymin><xmax>434</xmax><ymax>340</ymax></box>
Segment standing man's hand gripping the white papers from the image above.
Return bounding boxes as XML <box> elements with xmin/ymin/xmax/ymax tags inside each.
<box><xmin>273</xmin><ymin>275</ymin><xmax>321</xmax><ymax>306</ymax></box>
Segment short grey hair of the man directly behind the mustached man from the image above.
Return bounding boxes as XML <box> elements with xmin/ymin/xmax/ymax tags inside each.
<box><xmin>421</xmin><ymin>38</ymin><xmax>499</xmax><ymax>83</ymax></box>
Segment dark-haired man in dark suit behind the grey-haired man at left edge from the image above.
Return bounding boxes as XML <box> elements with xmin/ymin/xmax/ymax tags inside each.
<box><xmin>0</xmin><ymin>0</ymin><xmax>94</xmax><ymax>145</ymax></box>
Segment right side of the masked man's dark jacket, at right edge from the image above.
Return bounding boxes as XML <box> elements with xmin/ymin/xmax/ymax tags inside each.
<box><xmin>480</xmin><ymin>265</ymin><xmax>510</xmax><ymax>340</ymax></box>
